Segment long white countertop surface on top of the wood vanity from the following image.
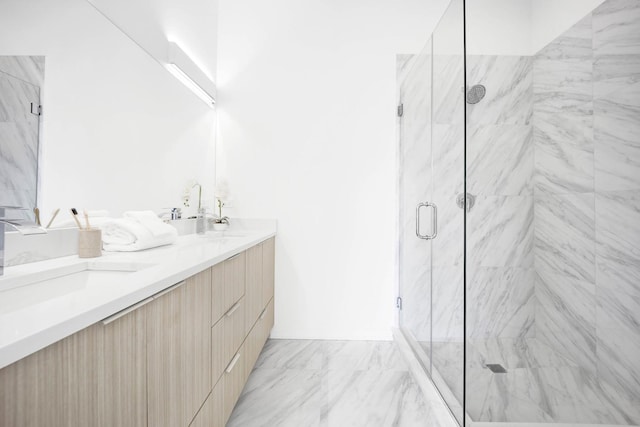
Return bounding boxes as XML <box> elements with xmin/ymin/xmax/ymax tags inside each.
<box><xmin>0</xmin><ymin>221</ymin><xmax>276</xmax><ymax>368</ymax></box>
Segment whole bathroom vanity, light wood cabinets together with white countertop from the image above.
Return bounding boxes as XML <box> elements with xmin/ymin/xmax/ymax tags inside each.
<box><xmin>0</xmin><ymin>229</ymin><xmax>275</xmax><ymax>427</ymax></box>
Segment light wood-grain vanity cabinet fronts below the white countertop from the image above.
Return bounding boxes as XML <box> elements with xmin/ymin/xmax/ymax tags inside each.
<box><xmin>0</xmin><ymin>238</ymin><xmax>274</xmax><ymax>427</ymax></box>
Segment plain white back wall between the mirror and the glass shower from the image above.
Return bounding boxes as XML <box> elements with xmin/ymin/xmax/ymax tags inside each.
<box><xmin>217</xmin><ymin>0</ymin><xmax>447</xmax><ymax>339</ymax></box>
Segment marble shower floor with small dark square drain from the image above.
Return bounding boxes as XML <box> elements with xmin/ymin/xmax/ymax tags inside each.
<box><xmin>421</xmin><ymin>339</ymin><xmax>640</xmax><ymax>425</ymax></box>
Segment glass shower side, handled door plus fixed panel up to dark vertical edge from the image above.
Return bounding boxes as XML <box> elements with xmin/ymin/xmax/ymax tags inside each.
<box><xmin>398</xmin><ymin>0</ymin><xmax>465</xmax><ymax>425</ymax></box>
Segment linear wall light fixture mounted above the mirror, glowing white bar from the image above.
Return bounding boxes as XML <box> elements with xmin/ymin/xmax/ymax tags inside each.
<box><xmin>167</xmin><ymin>42</ymin><xmax>216</xmax><ymax>107</ymax></box>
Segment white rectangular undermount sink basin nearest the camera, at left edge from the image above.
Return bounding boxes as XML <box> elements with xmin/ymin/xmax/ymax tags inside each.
<box><xmin>0</xmin><ymin>260</ymin><xmax>155</xmax><ymax>291</ymax></box>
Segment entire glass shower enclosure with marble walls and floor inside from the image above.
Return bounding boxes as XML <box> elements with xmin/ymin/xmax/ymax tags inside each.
<box><xmin>398</xmin><ymin>0</ymin><xmax>640</xmax><ymax>425</ymax></box>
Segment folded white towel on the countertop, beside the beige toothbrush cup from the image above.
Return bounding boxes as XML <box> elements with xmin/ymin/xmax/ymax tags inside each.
<box><xmin>101</xmin><ymin>218</ymin><xmax>178</xmax><ymax>252</ymax></box>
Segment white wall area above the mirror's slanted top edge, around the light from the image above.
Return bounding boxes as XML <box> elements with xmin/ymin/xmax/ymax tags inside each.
<box><xmin>88</xmin><ymin>0</ymin><xmax>218</xmax><ymax>80</ymax></box>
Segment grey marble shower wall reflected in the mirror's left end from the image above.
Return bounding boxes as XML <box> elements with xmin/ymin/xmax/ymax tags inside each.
<box><xmin>0</xmin><ymin>56</ymin><xmax>45</xmax><ymax>221</ymax></box>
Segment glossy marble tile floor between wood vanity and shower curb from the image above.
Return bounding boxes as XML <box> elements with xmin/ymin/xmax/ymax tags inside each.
<box><xmin>227</xmin><ymin>340</ymin><xmax>448</xmax><ymax>427</ymax></box>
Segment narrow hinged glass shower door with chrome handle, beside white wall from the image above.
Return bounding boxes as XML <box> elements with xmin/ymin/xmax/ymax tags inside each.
<box><xmin>398</xmin><ymin>32</ymin><xmax>436</xmax><ymax>378</ymax></box>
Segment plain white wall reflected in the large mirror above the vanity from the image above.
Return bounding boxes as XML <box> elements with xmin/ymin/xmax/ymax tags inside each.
<box><xmin>0</xmin><ymin>0</ymin><xmax>215</xmax><ymax>217</ymax></box>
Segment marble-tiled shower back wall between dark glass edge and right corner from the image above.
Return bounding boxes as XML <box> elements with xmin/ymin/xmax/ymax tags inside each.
<box><xmin>460</xmin><ymin>55</ymin><xmax>536</xmax><ymax>340</ymax></box>
